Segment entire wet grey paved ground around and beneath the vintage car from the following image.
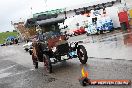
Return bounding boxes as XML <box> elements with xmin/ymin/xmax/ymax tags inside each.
<box><xmin>0</xmin><ymin>32</ymin><xmax>132</xmax><ymax>88</ymax></box>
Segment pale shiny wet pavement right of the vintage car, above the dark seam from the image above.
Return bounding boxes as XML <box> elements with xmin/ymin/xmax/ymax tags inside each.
<box><xmin>80</xmin><ymin>32</ymin><xmax>132</xmax><ymax>60</ymax></box>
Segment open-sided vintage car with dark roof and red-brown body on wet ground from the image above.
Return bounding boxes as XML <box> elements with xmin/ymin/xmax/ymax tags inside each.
<box><xmin>26</xmin><ymin>13</ymin><xmax>88</xmax><ymax>73</ymax></box>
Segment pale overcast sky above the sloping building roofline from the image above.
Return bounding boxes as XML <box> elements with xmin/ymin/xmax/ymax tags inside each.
<box><xmin>0</xmin><ymin>0</ymin><xmax>93</xmax><ymax>32</ymax></box>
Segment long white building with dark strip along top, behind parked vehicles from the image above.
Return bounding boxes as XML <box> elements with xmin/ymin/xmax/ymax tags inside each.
<box><xmin>34</xmin><ymin>0</ymin><xmax>131</xmax><ymax>28</ymax></box>
